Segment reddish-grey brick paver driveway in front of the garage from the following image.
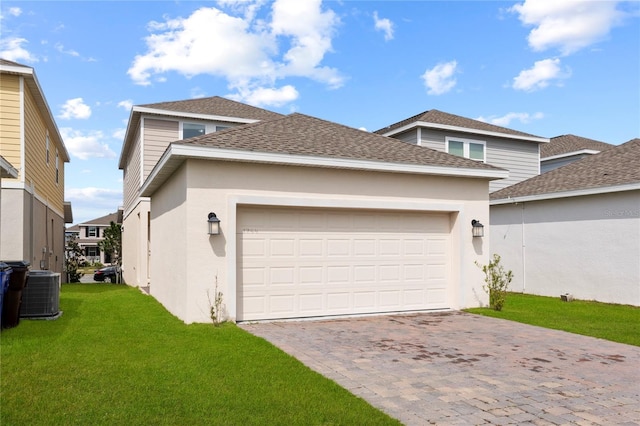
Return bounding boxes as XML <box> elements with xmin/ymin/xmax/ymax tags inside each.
<box><xmin>241</xmin><ymin>312</ymin><xmax>640</xmax><ymax>425</ymax></box>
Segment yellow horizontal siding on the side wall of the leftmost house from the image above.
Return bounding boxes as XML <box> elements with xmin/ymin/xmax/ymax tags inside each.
<box><xmin>24</xmin><ymin>82</ymin><xmax>64</xmax><ymax>212</ymax></box>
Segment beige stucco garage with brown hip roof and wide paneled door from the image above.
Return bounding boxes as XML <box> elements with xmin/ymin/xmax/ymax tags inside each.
<box><xmin>138</xmin><ymin>110</ymin><xmax>508</xmax><ymax>323</ymax></box>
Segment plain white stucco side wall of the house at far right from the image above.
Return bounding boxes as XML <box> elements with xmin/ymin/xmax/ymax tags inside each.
<box><xmin>491</xmin><ymin>191</ymin><xmax>640</xmax><ymax>306</ymax></box>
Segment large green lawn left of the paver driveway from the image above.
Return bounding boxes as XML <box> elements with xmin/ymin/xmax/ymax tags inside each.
<box><xmin>0</xmin><ymin>284</ymin><xmax>399</xmax><ymax>426</ymax></box>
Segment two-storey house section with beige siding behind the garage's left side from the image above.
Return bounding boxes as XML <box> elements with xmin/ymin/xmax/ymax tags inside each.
<box><xmin>118</xmin><ymin>96</ymin><xmax>280</xmax><ymax>287</ymax></box>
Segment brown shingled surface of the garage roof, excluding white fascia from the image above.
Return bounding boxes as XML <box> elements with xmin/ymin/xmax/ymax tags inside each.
<box><xmin>175</xmin><ymin>113</ymin><xmax>502</xmax><ymax>170</ymax></box>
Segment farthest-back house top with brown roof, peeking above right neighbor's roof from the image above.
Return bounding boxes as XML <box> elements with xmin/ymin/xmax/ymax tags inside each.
<box><xmin>540</xmin><ymin>135</ymin><xmax>613</xmax><ymax>173</ymax></box>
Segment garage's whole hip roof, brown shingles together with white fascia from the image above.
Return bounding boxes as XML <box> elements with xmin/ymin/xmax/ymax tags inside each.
<box><xmin>142</xmin><ymin>113</ymin><xmax>508</xmax><ymax>196</ymax></box>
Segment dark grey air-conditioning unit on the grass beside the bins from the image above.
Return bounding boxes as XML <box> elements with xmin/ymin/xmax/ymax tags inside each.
<box><xmin>20</xmin><ymin>270</ymin><xmax>61</xmax><ymax>318</ymax></box>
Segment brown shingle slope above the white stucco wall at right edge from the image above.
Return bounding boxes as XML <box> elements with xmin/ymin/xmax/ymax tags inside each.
<box><xmin>490</xmin><ymin>139</ymin><xmax>640</xmax><ymax>200</ymax></box>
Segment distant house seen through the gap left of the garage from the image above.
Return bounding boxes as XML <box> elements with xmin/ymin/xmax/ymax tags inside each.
<box><xmin>66</xmin><ymin>210</ymin><xmax>122</xmax><ymax>265</ymax></box>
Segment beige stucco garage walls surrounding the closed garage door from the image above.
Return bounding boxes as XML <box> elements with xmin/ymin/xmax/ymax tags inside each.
<box><xmin>151</xmin><ymin>160</ymin><xmax>489</xmax><ymax>323</ymax></box>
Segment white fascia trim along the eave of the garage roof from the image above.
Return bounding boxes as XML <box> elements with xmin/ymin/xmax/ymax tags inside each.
<box><xmin>140</xmin><ymin>144</ymin><xmax>509</xmax><ymax>196</ymax></box>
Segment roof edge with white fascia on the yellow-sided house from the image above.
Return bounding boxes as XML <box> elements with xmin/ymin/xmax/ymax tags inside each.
<box><xmin>0</xmin><ymin>58</ymin><xmax>70</xmax><ymax>163</ymax></box>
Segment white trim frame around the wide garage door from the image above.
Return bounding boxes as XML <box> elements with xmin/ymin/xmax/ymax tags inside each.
<box><xmin>222</xmin><ymin>195</ymin><xmax>465</xmax><ymax>322</ymax></box>
